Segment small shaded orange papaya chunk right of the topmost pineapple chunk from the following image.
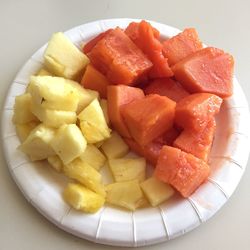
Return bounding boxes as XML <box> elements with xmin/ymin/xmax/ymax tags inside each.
<box><xmin>81</xmin><ymin>64</ymin><xmax>111</xmax><ymax>98</ymax></box>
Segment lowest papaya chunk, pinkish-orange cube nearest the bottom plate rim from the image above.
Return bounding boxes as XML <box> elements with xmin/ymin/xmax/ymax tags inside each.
<box><xmin>154</xmin><ymin>146</ymin><xmax>210</xmax><ymax>197</ymax></box>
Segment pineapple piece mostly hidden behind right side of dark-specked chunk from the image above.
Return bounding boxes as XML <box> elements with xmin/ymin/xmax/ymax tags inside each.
<box><xmin>67</xmin><ymin>80</ymin><xmax>99</xmax><ymax>114</ymax></box>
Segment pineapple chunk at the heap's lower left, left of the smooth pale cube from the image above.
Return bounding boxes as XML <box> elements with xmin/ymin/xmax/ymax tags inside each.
<box><xmin>19</xmin><ymin>124</ymin><xmax>55</xmax><ymax>161</ymax></box>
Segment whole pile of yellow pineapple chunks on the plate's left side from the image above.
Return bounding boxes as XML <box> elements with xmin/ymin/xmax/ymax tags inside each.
<box><xmin>13</xmin><ymin>33</ymin><xmax>174</xmax><ymax>213</ymax></box>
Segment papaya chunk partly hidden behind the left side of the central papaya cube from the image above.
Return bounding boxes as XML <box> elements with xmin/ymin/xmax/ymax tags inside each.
<box><xmin>107</xmin><ymin>85</ymin><xmax>144</xmax><ymax>138</ymax></box>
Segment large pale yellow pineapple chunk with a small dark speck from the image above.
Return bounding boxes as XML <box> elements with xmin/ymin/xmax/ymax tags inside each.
<box><xmin>29</xmin><ymin>76</ymin><xmax>79</xmax><ymax>112</ymax></box>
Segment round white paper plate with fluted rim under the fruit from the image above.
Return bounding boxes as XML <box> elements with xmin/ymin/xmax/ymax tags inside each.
<box><xmin>2</xmin><ymin>19</ymin><xmax>250</xmax><ymax>247</ymax></box>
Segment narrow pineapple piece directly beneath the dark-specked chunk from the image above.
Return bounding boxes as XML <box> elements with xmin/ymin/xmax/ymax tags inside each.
<box><xmin>31</xmin><ymin>102</ymin><xmax>77</xmax><ymax>128</ymax></box>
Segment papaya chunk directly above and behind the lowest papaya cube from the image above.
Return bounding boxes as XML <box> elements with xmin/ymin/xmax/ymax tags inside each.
<box><xmin>173</xmin><ymin>118</ymin><xmax>216</xmax><ymax>162</ymax></box>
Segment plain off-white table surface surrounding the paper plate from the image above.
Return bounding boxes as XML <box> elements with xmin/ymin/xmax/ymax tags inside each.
<box><xmin>0</xmin><ymin>0</ymin><xmax>250</xmax><ymax>250</ymax></box>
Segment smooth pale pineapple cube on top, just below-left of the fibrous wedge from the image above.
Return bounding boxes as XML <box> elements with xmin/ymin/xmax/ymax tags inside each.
<box><xmin>51</xmin><ymin>124</ymin><xmax>87</xmax><ymax>164</ymax></box>
